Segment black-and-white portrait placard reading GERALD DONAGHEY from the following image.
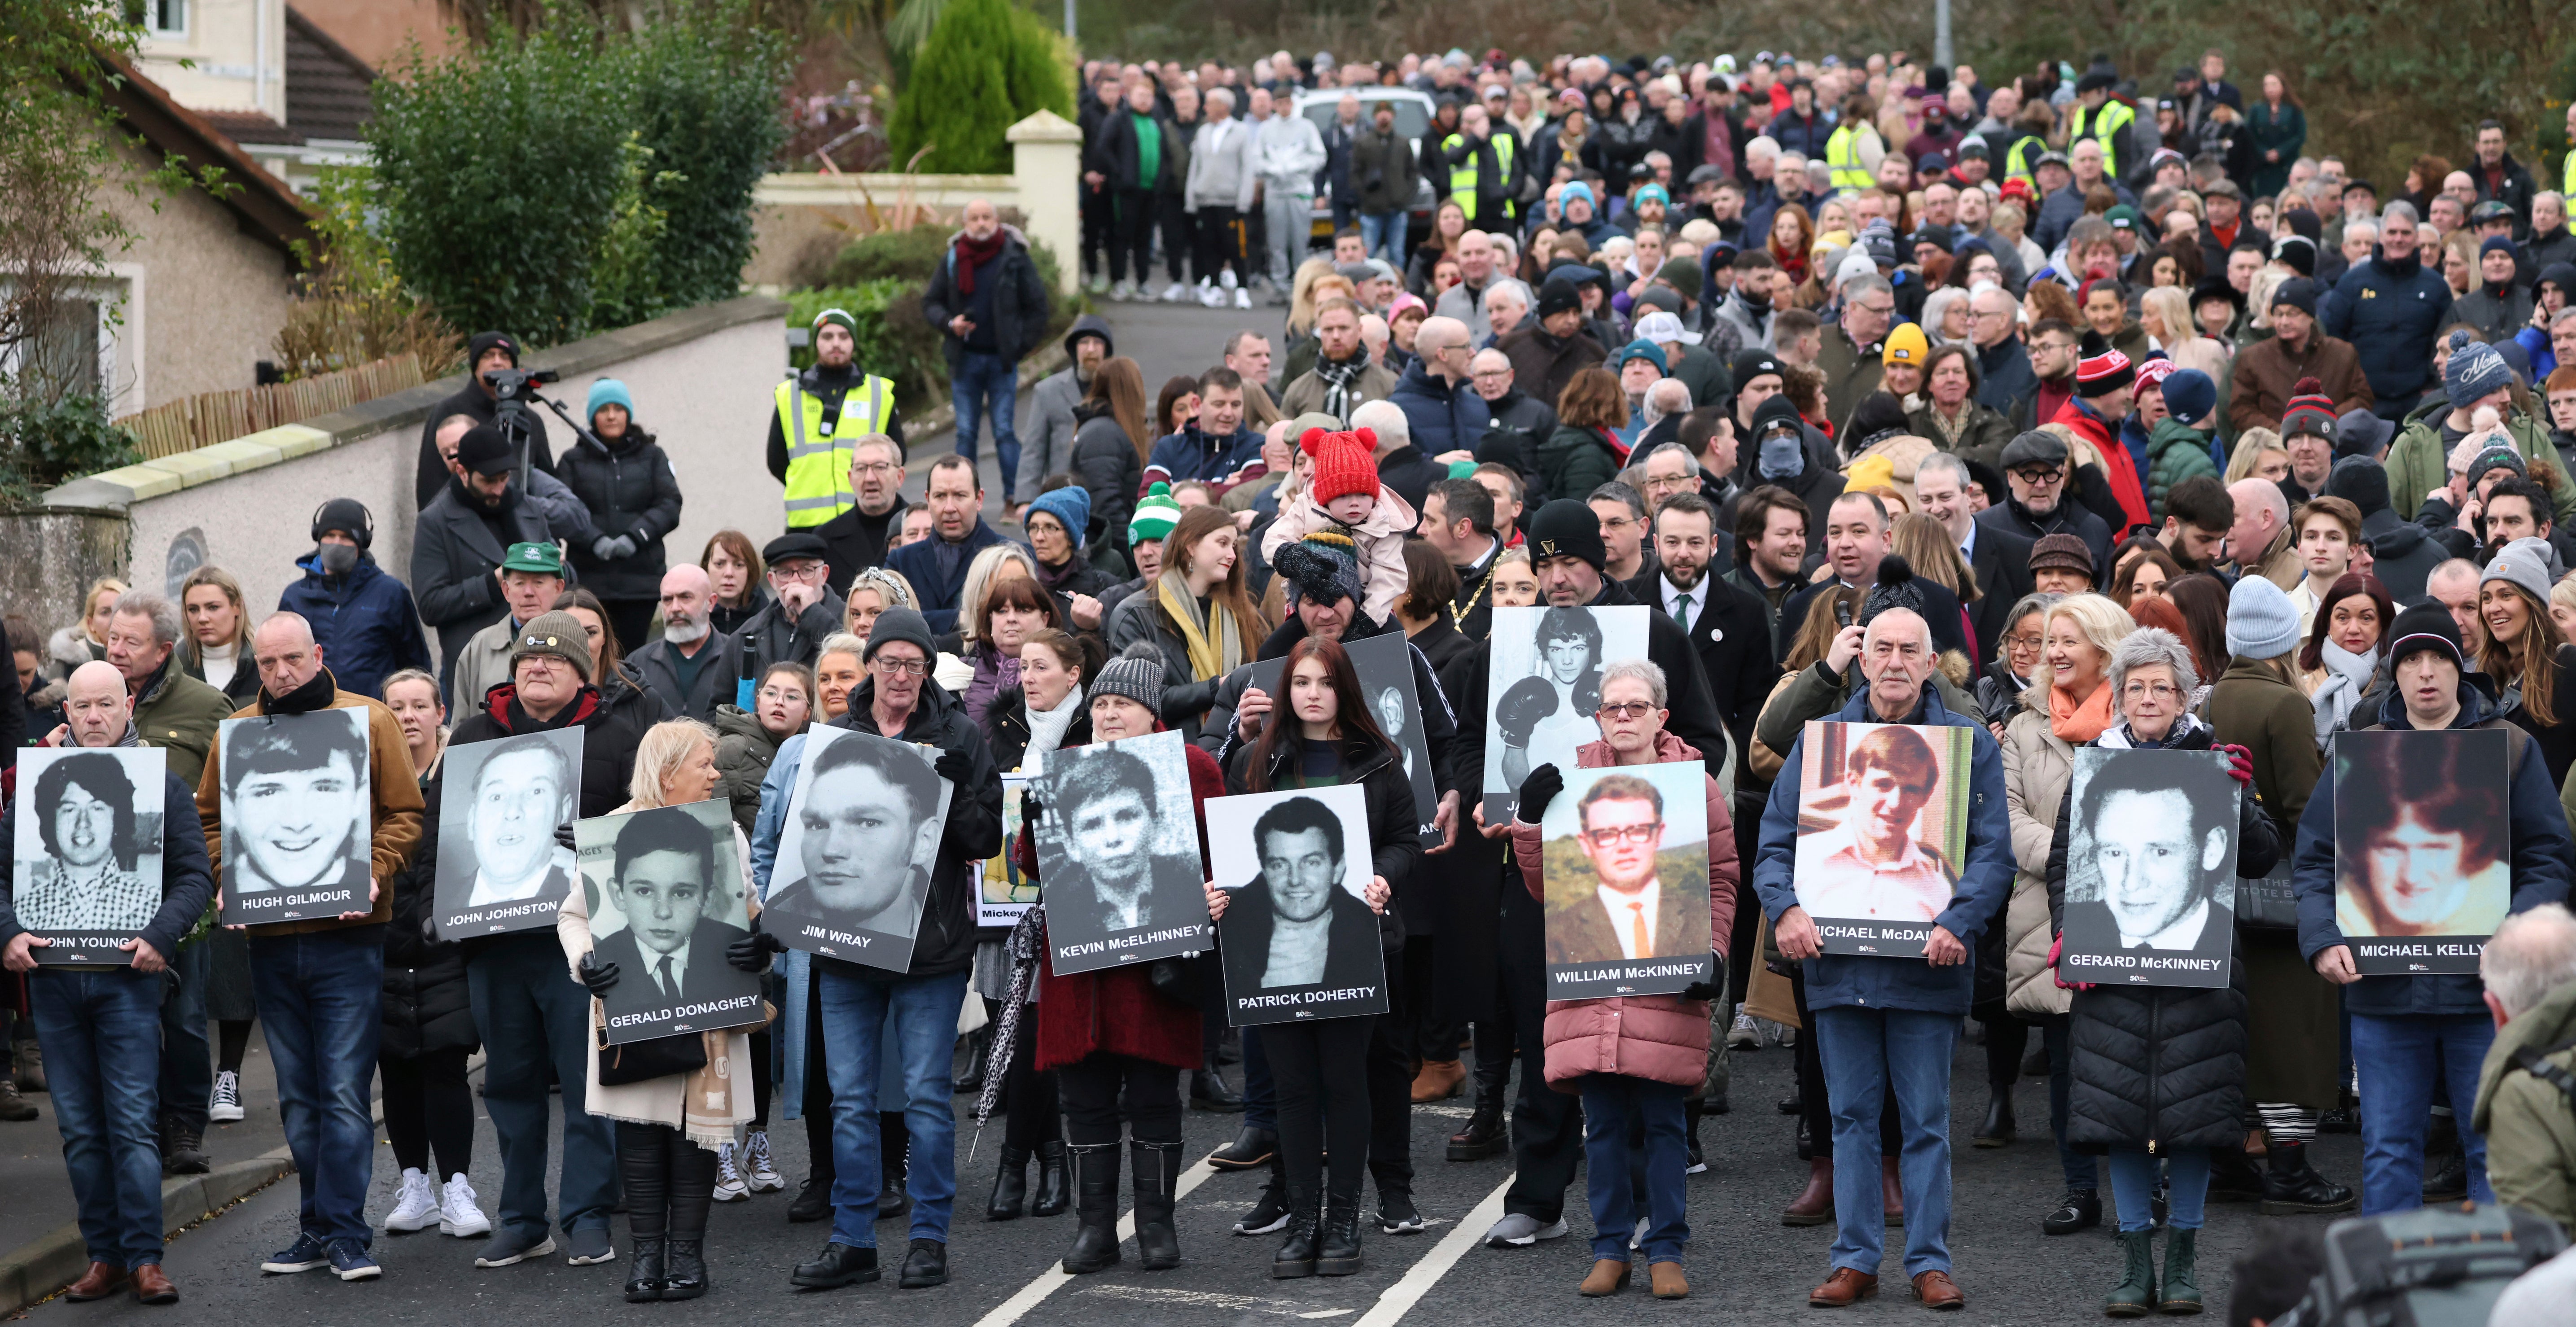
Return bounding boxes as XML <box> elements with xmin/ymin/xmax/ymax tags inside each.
<box><xmin>572</xmin><ymin>801</ymin><xmax>762</xmax><ymax>1046</ymax></box>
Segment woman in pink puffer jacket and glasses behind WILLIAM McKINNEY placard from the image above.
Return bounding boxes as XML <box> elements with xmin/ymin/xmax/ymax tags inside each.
<box><xmin>1512</xmin><ymin>660</ymin><xmax>1739</xmax><ymax>1299</ymax></box>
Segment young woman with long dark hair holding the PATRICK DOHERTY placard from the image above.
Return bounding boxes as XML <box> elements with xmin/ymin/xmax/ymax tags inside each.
<box><xmin>1200</xmin><ymin>636</ymin><xmax>1422</xmax><ymax>1278</ymax></box>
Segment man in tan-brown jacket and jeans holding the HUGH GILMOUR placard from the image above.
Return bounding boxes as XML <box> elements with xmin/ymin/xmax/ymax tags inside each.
<box><xmin>196</xmin><ymin>613</ymin><xmax>422</xmax><ymax>1281</ymax></box>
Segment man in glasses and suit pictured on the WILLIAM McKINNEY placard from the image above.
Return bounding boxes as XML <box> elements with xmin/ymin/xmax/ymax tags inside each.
<box><xmin>1548</xmin><ymin>773</ymin><xmax>1710</xmax><ymax>966</ymax></box>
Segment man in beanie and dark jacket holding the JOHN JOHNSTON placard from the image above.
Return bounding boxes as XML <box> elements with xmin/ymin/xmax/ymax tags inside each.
<box><xmin>430</xmin><ymin>608</ymin><xmax>662</xmax><ymax>1268</ymax></box>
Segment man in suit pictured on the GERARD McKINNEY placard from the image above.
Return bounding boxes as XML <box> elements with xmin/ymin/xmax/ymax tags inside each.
<box><xmin>2061</xmin><ymin>760</ymin><xmax>2236</xmax><ymax>972</ymax></box>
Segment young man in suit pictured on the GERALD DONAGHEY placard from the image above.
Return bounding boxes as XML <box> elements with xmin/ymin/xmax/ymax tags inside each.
<box><xmin>592</xmin><ymin>814</ymin><xmax>747</xmax><ymax>1007</ymax></box>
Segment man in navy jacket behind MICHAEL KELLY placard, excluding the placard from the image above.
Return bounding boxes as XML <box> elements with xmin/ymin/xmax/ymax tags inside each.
<box><xmin>2293</xmin><ymin>603</ymin><xmax>2576</xmax><ymax>1216</ymax></box>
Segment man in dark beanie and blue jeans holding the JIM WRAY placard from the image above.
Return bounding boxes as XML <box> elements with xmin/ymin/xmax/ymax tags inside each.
<box><xmin>752</xmin><ymin>608</ymin><xmax>1002</xmax><ymax>1288</ymax></box>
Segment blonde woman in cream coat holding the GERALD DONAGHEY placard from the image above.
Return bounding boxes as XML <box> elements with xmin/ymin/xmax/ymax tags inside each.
<box><xmin>554</xmin><ymin>719</ymin><xmax>762</xmax><ymax>1304</ymax></box>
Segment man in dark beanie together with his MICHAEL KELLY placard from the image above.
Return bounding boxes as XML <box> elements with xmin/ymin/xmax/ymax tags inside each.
<box><xmin>2295</xmin><ymin>603</ymin><xmax>2576</xmax><ymax>1216</ymax></box>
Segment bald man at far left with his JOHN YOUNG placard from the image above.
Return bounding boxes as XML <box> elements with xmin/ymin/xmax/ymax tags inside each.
<box><xmin>0</xmin><ymin>662</ymin><xmax>214</xmax><ymax>1304</ymax></box>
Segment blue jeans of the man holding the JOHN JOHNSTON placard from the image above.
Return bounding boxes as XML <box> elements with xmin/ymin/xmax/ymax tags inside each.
<box><xmin>466</xmin><ymin>930</ymin><xmax>618</xmax><ymax>1239</ymax></box>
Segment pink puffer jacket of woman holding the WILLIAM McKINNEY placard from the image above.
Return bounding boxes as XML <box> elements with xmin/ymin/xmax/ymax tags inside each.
<box><xmin>1512</xmin><ymin>732</ymin><xmax>1741</xmax><ymax>1093</ymax></box>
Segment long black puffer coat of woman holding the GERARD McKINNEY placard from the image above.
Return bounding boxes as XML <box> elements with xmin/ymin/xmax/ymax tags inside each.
<box><xmin>2048</xmin><ymin>724</ymin><xmax>2280</xmax><ymax>1154</ymax></box>
